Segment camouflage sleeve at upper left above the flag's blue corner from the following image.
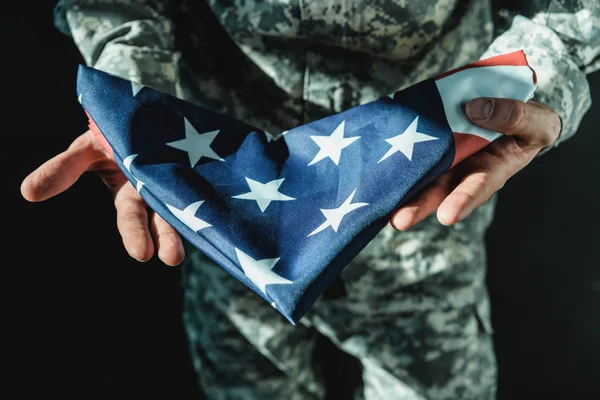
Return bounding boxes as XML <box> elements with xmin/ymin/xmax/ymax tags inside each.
<box><xmin>54</xmin><ymin>0</ymin><xmax>181</xmax><ymax>96</ymax></box>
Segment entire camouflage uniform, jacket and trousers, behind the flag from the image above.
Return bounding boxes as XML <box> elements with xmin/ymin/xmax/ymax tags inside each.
<box><xmin>56</xmin><ymin>0</ymin><xmax>600</xmax><ymax>400</ymax></box>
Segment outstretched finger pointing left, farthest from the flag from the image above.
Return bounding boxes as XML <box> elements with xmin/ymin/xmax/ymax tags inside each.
<box><xmin>21</xmin><ymin>132</ymin><xmax>104</xmax><ymax>201</ymax></box>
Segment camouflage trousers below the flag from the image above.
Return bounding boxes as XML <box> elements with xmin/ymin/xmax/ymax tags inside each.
<box><xmin>184</xmin><ymin>200</ymin><xmax>496</xmax><ymax>400</ymax></box>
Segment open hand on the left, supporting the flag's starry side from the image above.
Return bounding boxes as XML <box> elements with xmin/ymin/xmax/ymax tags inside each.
<box><xmin>21</xmin><ymin>131</ymin><xmax>184</xmax><ymax>265</ymax></box>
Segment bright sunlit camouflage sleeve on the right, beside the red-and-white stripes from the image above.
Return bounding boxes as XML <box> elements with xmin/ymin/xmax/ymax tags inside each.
<box><xmin>482</xmin><ymin>0</ymin><xmax>600</xmax><ymax>154</ymax></box>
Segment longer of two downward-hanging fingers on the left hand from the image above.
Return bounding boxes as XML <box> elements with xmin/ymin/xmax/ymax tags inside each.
<box><xmin>115</xmin><ymin>182</ymin><xmax>154</xmax><ymax>261</ymax></box>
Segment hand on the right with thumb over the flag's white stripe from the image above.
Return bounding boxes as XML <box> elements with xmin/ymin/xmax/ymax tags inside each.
<box><xmin>391</xmin><ymin>98</ymin><xmax>561</xmax><ymax>230</ymax></box>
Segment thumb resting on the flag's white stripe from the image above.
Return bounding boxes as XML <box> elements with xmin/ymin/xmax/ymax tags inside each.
<box><xmin>465</xmin><ymin>97</ymin><xmax>560</xmax><ymax>148</ymax></box>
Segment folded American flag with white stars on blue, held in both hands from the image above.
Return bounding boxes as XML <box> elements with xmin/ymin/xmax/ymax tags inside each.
<box><xmin>77</xmin><ymin>51</ymin><xmax>535</xmax><ymax>323</ymax></box>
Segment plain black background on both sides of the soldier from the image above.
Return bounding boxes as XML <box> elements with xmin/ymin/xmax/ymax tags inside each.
<box><xmin>0</xmin><ymin>1</ymin><xmax>600</xmax><ymax>399</ymax></box>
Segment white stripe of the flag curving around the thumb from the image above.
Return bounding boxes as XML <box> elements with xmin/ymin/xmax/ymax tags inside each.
<box><xmin>435</xmin><ymin>65</ymin><xmax>535</xmax><ymax>142</ymax></box>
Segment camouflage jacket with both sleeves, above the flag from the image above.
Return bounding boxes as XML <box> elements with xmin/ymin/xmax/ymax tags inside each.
<box><xmin>55</xmin><ymin>0</ymin><xmax>600</xmax><ymax>152</ymax></box>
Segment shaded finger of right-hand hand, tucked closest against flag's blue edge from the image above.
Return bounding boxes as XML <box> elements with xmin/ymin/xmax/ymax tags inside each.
<box><xmin>390</xmin><ymin>171</ymin><xmax>454</xmax><ymax>231</ymax></box>
